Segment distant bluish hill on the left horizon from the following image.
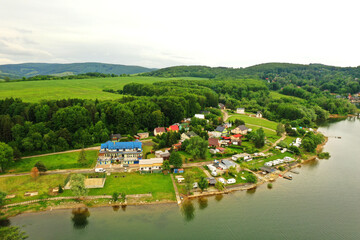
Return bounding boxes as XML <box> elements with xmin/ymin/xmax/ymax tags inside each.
<box><xmin>0</xmin><ymin>62</ymin><xmax>156</xmax><ymax>78</ymax></box>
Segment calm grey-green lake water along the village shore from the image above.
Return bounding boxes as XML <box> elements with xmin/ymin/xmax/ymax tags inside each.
<box><xmin>7</xmin><ymin>119</ymin><xmax>360</xmax><ymax>240</ymax></box>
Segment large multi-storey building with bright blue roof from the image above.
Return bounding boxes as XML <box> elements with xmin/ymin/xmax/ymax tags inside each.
<box><xmin>98</xmin><ymin>140</ymin><xmax>142</xmax><ymax>166</ymax></box>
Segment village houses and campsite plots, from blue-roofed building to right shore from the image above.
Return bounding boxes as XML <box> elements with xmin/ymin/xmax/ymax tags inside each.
<box><xmin>88</xmin><ymin>104</ymin><xmax>313</xmax><ymax>202</ymax></box>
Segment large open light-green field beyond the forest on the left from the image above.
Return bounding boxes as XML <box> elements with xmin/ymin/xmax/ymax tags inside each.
<box><xmin>0</xmin><ymin>76</ymin><xmax>202</xmax><ymax>102</ymax></box>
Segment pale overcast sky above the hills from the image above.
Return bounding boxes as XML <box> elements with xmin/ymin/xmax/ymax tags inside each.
<box><xmin>0</xmin><ymin>0</ymin><xmax>360</xmax><ymax>68</ymax></box>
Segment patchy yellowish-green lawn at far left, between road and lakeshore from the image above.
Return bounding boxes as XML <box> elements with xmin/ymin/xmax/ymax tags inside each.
<box><xmin>0</xmin><ymin>174</ymin><xmax>67</xmax><ymax>204</ymax></box>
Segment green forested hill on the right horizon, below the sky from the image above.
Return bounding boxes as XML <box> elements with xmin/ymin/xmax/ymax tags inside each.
<box><xmin>142</xmin><ymin>63</ymin><xmax>360</xmax><ymax>94</ymax></box>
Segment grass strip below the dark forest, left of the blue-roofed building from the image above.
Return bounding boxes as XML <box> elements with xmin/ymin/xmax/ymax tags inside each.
<box><xmin>8</xmin><ymin>150</ymin><xmax>98</xmax><ymax>172</ymax></box>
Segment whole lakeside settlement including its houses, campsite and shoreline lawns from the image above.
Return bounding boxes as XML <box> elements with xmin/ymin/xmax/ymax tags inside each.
<box><xmin>0</xmin><ymin>104</ymin><xmax>315</xmax><ymax>213</ymax></box>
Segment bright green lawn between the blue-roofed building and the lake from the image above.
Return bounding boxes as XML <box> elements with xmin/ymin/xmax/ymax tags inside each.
<box><xmin>84</xmin><ymin>173</ymin><xmax>175</xmax><ymax>200</ymax></box>
